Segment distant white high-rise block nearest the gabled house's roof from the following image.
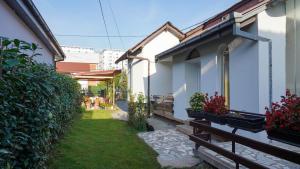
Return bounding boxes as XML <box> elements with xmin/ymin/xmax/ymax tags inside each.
<box><xmin>98</xmin><ymin>49</ymin><xmax>127</xmax><ymax>70</ymax></box>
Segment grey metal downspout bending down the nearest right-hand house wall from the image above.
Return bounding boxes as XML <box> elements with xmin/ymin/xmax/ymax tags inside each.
<box><xmin>233</xmin><ymin>12</ymin><xmax>273</xmax><ymax>108</ymax></box>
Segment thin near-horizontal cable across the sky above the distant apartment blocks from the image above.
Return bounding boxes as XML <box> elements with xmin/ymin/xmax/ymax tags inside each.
<box><xmin>55</xmin><ymin>34</ymin><xmax>147</xmax><ymax>38</ymax></box>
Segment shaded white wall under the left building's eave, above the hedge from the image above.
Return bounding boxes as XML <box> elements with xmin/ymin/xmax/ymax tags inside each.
<box><xmin>0</xmin><ymin>0</ymin><xmax>54</xmax><ymax>65</ymax></box>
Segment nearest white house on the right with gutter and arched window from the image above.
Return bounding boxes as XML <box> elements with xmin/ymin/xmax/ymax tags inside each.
<box><xmin>154</xmin><ymin>0</ymin><xmax>300</xmax><ymax>123</ymax></box>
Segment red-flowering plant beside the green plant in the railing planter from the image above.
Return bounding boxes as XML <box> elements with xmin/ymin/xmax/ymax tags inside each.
<box><xmin>204</xmin><ymin>92</ymin><xmax>228</xmax><ymax>115</ymax></box>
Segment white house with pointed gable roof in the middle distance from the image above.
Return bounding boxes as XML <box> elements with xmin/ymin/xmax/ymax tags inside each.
<box><xmin>116</xmin><ymin>22</ymin><xmax>184</xmax><ymax>99</ymax></box>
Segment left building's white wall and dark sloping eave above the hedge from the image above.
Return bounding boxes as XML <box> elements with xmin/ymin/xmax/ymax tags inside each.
<box><xmin>0</xmin><ymin>0</ymin><xmax>65</xmax><ymax>65</ymax></box>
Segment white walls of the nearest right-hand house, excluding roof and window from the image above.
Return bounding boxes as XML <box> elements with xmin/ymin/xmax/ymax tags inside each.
<box><xmin>172</xmin><ymin>3</ymin><xmax>286</xmax><ymax>119</ymax></box>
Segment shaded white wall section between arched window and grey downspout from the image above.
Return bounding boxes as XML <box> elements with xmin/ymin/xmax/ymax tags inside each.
<box><xmin>229</xmin><ymin>22</ymin><xmax>260</xmax><ymax>113</ymax></box>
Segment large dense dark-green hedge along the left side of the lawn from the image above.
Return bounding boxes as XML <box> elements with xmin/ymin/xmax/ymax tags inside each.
<box><xmin>0</xmin><ymin>40</ymin><xmax>81</xmax><ymax>169</ymax></box>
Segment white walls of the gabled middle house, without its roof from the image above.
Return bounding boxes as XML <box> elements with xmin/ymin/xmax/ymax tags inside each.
<box><xmin>128</xmin><ymin>31</ymin><xmax>179</xmax><ymax>95</ymax></box>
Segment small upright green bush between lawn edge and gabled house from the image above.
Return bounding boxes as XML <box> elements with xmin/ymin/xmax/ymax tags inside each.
<box><xmin>128</xmin><ymin>94</ymin><xmax>147</xmax><ymax>131</ymax></box>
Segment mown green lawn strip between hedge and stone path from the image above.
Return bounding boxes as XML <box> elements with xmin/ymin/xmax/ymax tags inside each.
<box><xmin>49</xmin><ymin>111</ymin><xmax>160</xmax><ymax>169</ymax></box>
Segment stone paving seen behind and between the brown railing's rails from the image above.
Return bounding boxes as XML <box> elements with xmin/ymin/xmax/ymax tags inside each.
<box><xmin>199</xmin><ymin>142</ymin><xmax>300</xmax><ymax>169</ymax></box>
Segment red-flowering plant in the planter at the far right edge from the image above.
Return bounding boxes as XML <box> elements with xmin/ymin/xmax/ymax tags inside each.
<box><xmin>266</xmin><ymin>90</ymin><xmax>300</xmax><ymax>131</ymax></box>
